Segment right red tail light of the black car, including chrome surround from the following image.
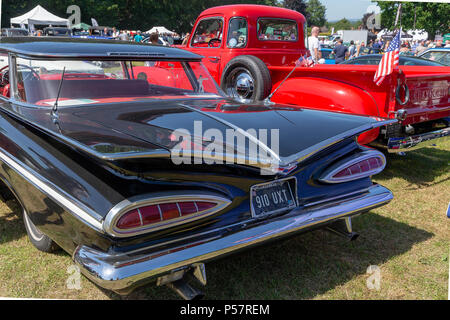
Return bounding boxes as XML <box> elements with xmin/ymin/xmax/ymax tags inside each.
<box><xmin>319</xmin><ymin>150</ymin><xmax>386</xmax><ymax>183</ymax></box>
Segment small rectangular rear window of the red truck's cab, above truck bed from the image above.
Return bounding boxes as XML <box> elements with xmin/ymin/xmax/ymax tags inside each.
<box><xmin>258</xmin><ymin>18</ymin><xmax>298</xmax><ymax>41</ymax></box>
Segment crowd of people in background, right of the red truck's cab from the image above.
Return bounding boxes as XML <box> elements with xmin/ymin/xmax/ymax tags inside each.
<box><xmin>308</xmin><ymin>27</ymin><xmax>450</xmax><ymax>63</ymax></box>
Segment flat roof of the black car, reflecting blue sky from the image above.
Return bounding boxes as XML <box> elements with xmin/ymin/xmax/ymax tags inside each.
<box><xmin>0</xmin><ymin>37</ymin><xmax>202</xmax><ymax>61</ymax></box>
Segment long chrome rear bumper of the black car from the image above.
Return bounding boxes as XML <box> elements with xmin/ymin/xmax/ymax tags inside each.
<box><xmin>73</xmin><ymin>185</ymin><xmax>393</xmax><ymax>294</ymax></box>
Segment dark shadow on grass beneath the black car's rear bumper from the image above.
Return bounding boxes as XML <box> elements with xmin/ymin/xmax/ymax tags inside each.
<box><xmin>128</xmin><ymin>213</ymin><xmax>433</xmax><ymax>299</ymax></box>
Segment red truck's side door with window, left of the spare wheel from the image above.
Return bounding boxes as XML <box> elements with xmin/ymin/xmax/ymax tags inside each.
<box><xmin>189</xmin><ymin>17</ymin><xmax>224</xmax><ymax>83</ymax></box>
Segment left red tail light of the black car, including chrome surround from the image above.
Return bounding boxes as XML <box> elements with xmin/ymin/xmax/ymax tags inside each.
<box><xmin>104</xmin><ymin>195</ymin><xmax>231</xmax><ymax>236</ymax></box>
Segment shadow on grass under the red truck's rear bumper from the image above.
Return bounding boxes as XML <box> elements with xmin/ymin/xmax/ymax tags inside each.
<box><xmin>376</xmin><ymin>148</ymin><xmax>450</xmax><ymax>190</ymax></box>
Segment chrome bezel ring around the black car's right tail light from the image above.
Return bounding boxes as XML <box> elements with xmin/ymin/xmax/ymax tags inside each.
<box><xmin>319</xmin><ymin>150</ymin><xmax>386</xmax><ymax>183</ymax></box>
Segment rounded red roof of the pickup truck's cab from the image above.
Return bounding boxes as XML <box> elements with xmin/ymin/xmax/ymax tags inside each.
<box><xmin>200</xmin><ymin>4</ymin><xmax>306</xmax><ymax>21</ymax></box>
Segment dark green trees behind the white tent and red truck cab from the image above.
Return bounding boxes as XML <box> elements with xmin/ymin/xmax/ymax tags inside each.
<box><xmin>2</xmin><ymin>0</ymin><xmax>277</xmax><ymax>33</ymax></box>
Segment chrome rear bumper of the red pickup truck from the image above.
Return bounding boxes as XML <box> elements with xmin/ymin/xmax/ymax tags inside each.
<box><xmin>387</xmin><ymin>127</ymin><xmax>450</xmax><ymax>153</ymax></box>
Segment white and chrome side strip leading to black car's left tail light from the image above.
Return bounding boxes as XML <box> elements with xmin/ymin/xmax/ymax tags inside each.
<box><xmin>0</xmin><ymin>149</ymin><xmax>103</xmax><ymax>233</ymax></box>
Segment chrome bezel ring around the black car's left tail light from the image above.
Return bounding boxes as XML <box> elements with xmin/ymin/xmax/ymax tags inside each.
<box><xmin>103</xmin><ymin>192</ymin><xmax>232</xmax><ymax>237</ymax></box>
